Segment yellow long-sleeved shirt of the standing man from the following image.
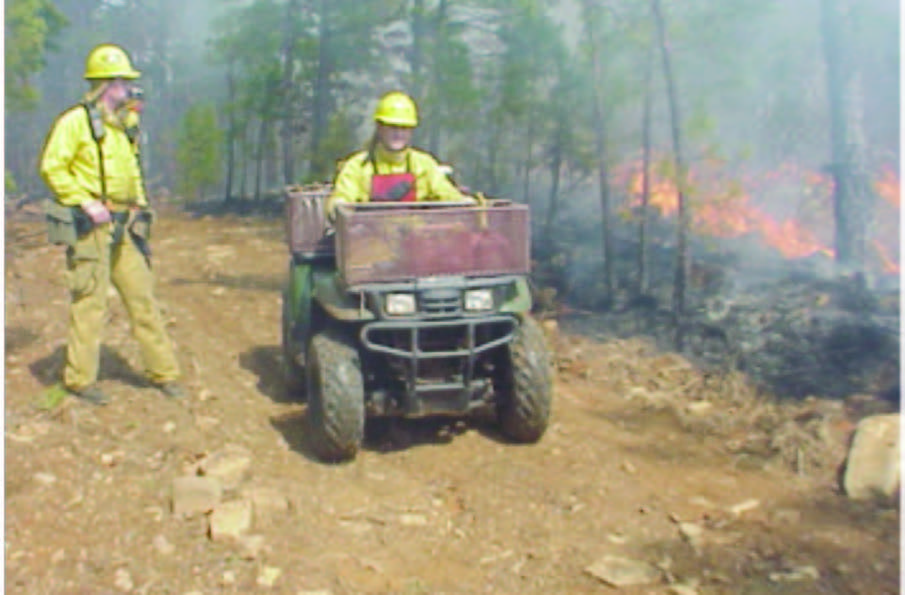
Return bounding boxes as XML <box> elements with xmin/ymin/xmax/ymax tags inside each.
<box><xmin>40</xmin><ymin>105</ymin><xmax>148</xmax><ymax>206</ymax></box>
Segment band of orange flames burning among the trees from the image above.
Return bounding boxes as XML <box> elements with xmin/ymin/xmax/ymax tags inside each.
<box><xmin>615</xmin><ymin>157</ymin><xmax>900</xmax><ymax>275</ymax></box>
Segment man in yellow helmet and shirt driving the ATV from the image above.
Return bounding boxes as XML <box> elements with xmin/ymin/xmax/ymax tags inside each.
<box><xmin>327</xmin><ymin>91</ymin><xmax>475</xmax><ymax>219</ymax></box>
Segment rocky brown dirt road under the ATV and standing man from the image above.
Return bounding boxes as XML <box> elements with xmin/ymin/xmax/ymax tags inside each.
<box><xmin>5</xmin><ymin>216</ymin><xmax>899</xmax><ymax>595</ymax></box>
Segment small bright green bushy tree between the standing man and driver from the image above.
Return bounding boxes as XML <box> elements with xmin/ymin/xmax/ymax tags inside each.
<box><xmin>176</xmin><ymin>103</ymin><xmax>223</xmax><ymax>199</ymax></box>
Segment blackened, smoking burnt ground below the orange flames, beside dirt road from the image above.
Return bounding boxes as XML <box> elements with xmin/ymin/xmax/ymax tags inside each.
<box><xmin>538</xmin><ymin>233</ymin><xmax>900</xmax><ymax>401</ymax></box>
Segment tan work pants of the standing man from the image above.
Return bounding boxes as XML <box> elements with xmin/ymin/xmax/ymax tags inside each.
<box><xmin>63</xmin><ymin>223</ymin><xmax>180</xmax><ymax>389</ymax></box>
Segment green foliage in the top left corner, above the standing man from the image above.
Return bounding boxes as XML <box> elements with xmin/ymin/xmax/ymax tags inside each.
<box><xmin>4</xmin><ymin>0</ymin><xmax>66</xmax><ymax>112</ymax></box>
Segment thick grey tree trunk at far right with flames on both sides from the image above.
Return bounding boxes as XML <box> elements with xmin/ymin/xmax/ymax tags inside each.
<box><xmin>821</xmin><ymin>0</ymin><xmax>874</xmax><ymax>280</ymax></box>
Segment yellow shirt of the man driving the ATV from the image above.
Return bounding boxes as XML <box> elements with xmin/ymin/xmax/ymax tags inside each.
<box><xmin>327</xmin><ymin>145</ymin><xmax>473</xmax><ymax>219</ymax></box>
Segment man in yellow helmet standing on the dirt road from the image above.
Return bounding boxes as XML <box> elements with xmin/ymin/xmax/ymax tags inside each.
<box><xmin>40</xmin><ymin>44</ymin><xmax>185</xmax><ymax>405</ymax></box>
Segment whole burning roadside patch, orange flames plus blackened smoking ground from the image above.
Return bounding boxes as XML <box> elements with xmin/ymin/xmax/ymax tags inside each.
<box><xmin>536</xmin><ymin>158</ymin><xmax>900</xmax><ymax>410</ymax></box>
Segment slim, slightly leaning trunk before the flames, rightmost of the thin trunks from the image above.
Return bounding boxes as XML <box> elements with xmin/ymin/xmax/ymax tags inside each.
<box><xmin>651</xmin><ymin>0</ymin><xmax>690</xmax><ymax>336</ymax></box>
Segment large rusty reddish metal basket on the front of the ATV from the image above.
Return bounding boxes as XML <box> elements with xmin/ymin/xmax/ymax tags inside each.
<box><xmin>336</xmin><ymin>201</ymin><xmax>530</xmax><ymax>286</ymax></box>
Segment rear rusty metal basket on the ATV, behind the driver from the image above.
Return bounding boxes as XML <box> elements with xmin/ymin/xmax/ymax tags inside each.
<box><xmin>285</xmin><ymin>186</ymin><xmax>334</xmax><ymax>257</ymax></box>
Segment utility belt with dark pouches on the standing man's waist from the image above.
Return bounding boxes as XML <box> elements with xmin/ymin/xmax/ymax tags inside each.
<box><xmin>44</xmin><ymin>200</ymin><xmax>154</xmax><ymax>265</ymax></box>
